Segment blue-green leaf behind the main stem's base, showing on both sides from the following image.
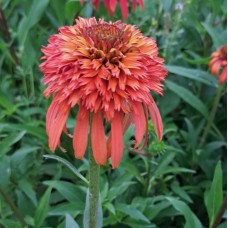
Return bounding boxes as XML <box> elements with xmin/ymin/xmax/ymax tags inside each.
<box><xmin>83</xmin><ymin>188</ymin><xmax>103</xmax><ymax>228</ymax></box>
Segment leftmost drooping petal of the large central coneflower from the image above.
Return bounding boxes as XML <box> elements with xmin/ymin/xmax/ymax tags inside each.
<box><xmin>47</xmin><ymin>102</ymin><xmax>70</xmax><ymax>151</ymax></box>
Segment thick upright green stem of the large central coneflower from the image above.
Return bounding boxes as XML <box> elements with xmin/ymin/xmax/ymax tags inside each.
<box><xmin>89</xmin><ymin>142</ymin><xmax>100</xmax><ymax>228</ymax></box>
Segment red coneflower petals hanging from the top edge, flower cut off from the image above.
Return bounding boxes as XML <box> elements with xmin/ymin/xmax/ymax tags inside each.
<box><xmin>80</xmin><ymin>0</ymin><xmax>144</xmax><ymax>20</ymax></box>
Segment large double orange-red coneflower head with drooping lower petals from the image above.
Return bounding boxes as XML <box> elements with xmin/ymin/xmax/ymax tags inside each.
<box><xmin>40</xmin><ymin>18</ymin><xmax>167</xmax><ymax>168</ymax></box>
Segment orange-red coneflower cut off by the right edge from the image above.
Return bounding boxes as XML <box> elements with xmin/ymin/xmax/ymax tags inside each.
<box><xmin>209</xmin><ymin>46</ymin><xmax>227</xmax><ymax>84</ymax></box>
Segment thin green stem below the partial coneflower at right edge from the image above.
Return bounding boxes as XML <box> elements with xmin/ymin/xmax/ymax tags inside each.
<box><xmin>199</xmin><ymin>85</ymin><xmax>223</xmax><ymax>148</ymax></box>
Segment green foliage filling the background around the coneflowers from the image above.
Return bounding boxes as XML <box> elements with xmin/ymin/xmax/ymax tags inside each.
<box><xmin>0</xmin><ymin>0</ymin><xmax>227</xmax><ymax>228</ymax></box>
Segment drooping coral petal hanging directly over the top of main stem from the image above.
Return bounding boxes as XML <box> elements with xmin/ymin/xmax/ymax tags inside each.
<box><xmin>91</xmin><ymin>110</ymin><xmax>107</xmax><ymax>165</ymax></box>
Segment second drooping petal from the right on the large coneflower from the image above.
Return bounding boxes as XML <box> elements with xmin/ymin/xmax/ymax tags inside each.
<box><xmin>132</xmin><ymin>102</ymin><xmax>146</xmax><ymax>148</ymax></box>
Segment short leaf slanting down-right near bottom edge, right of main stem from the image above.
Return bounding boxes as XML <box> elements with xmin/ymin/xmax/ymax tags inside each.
<box><xmin>115</xmin><ymin>203</ymin><xmax>150</xmax><ymax>223</ymax></box>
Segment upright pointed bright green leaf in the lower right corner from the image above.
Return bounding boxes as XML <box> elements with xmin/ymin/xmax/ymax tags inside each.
<box><xmin>205</xmin><ymin>161</ymin><xmax>223</xmax><ymax>227</ymax></box>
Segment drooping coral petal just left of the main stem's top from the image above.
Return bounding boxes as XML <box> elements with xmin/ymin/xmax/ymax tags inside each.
<box><xmin>73</xmin><ymin>106</ymin><xmax>89</xmax><ymax>159</ymax></box>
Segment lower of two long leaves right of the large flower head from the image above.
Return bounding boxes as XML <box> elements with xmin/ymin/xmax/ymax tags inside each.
<box><xmin>166</xmin><ymin>80</ymin><xmax>208</xmax><ymax>118</ymax></box>
